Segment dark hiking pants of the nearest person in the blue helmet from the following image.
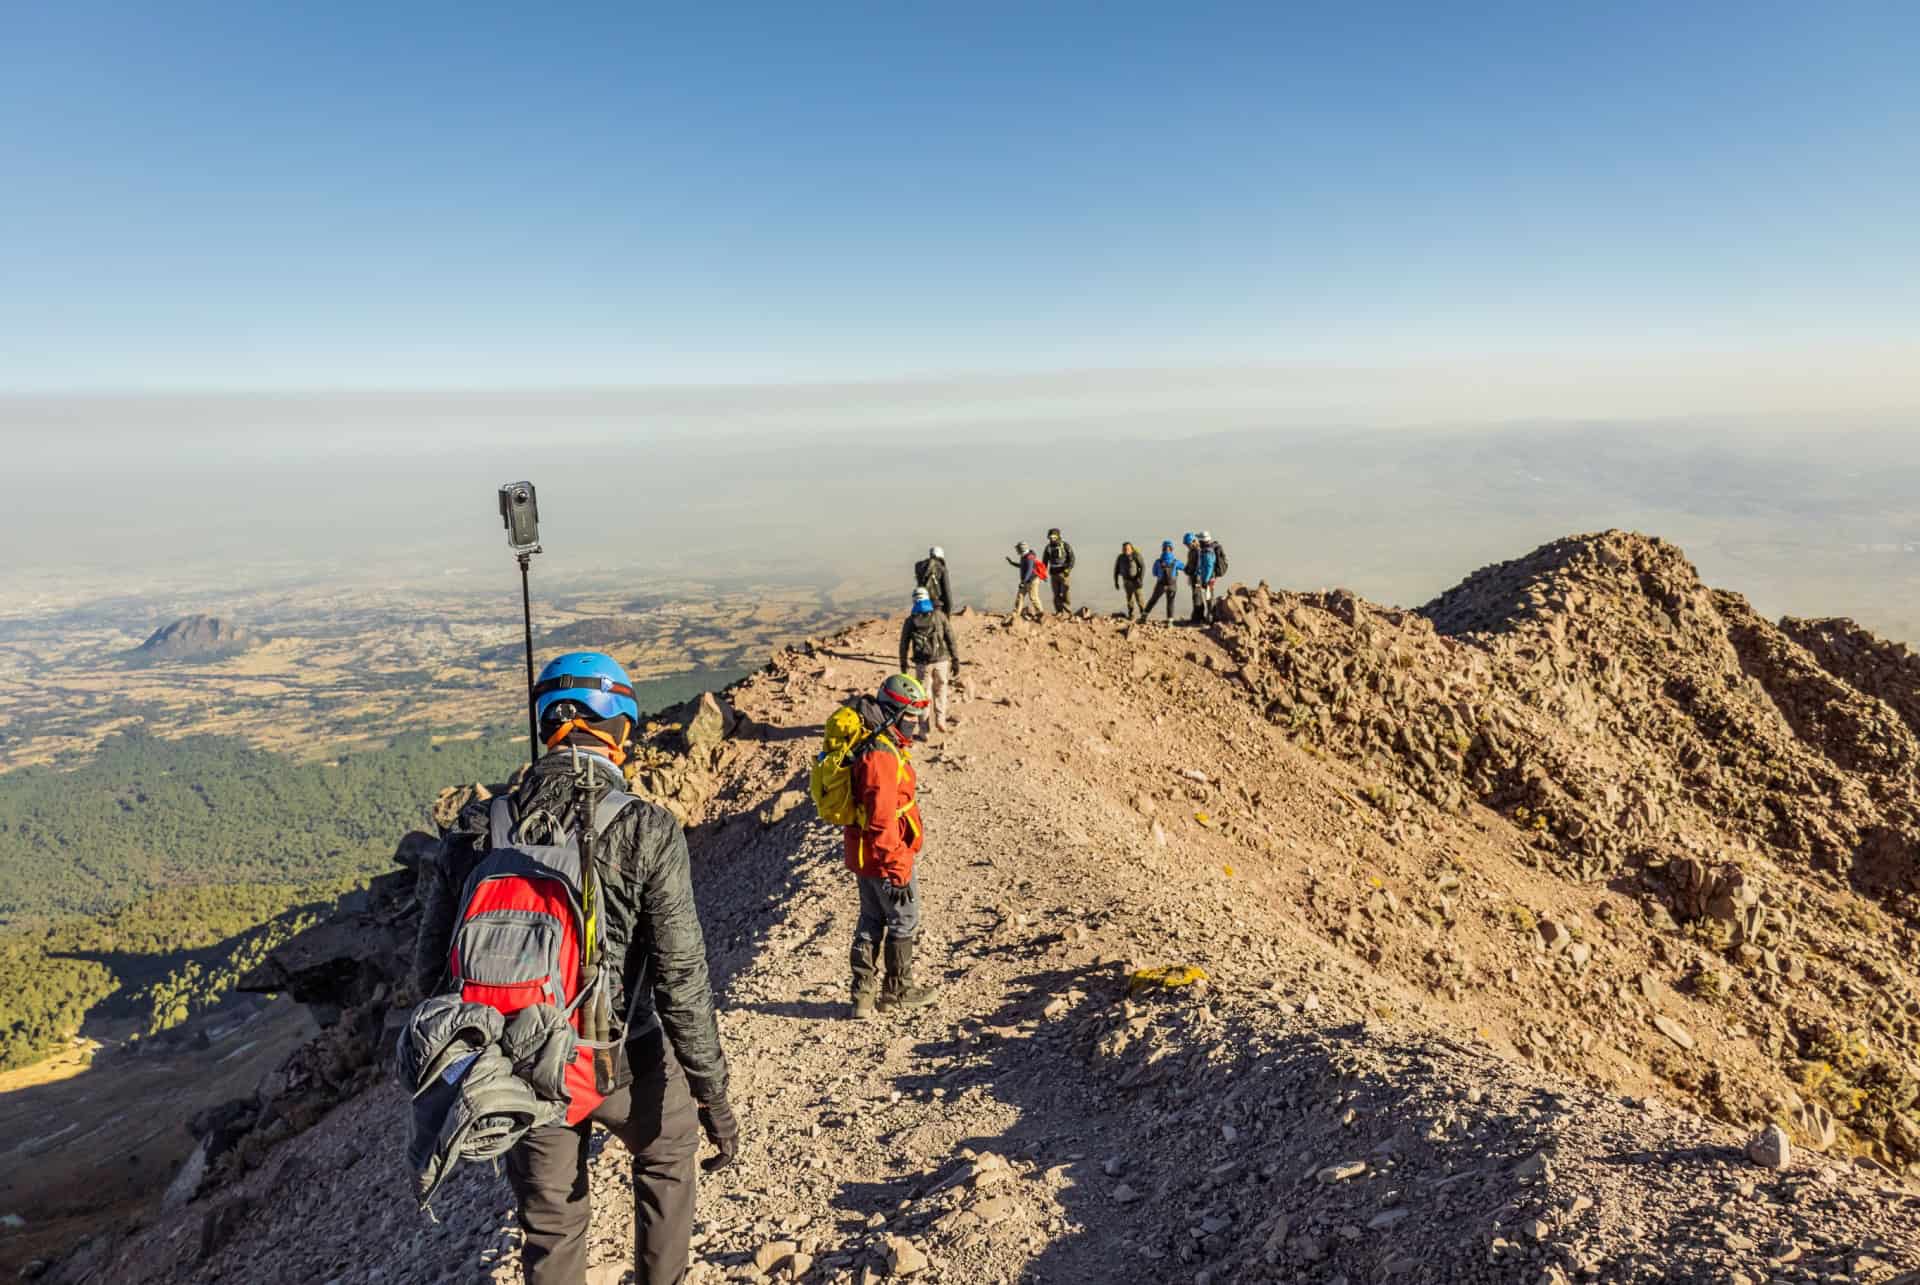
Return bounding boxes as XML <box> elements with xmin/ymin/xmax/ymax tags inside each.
<box><xmin>507</xmin><ymin>1031</ymin><xmax>701</xmax><ymax>1285</ymax></box>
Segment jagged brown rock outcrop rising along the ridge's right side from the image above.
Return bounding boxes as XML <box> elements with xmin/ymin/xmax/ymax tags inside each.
<box><xmin>1219</xmin><ymin>532</ymin><xmax>1920</xmax><ymax>1164</ymax></box>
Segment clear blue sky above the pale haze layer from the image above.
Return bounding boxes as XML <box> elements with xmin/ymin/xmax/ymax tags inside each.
<box><xmin>0</xmin><ymin>0</ymin><xmax>1920</xmax><ymax>390</ymax></box>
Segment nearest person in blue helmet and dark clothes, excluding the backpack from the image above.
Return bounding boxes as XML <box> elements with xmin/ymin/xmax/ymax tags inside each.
<box><xmin>413</xmin><ymin>651</ymin><xmax>739</xmax><ymax>1285</ymax></box>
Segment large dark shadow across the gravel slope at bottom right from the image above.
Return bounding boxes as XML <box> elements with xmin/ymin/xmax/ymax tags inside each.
<box><xmin>864</xmin><ymin>966</ymin><xmax>1920</xmax><ymax>1285</ymax></box>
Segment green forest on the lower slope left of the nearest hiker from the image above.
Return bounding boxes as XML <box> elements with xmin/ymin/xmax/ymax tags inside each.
<box><xmin>0</xmin><ymin>734</ymin><xmax>522</xmax><ymax>1070</ymax></box>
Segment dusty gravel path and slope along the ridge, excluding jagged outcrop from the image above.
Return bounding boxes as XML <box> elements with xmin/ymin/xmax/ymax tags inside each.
<box><xmin>60</xmin><ymin>615</ymin><xmax>1920</xmax><ymax>1285</ymax></box>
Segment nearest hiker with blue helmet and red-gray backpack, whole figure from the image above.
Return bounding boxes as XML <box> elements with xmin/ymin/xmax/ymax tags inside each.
<box><xmin>403</xmin><ymin>651</ymin><xmax>739</xmax><ymax>1285</ymax></box>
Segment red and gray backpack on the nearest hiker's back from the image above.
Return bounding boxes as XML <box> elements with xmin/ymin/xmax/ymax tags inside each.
<box><xmin>447</xmin><ymin>791</ymin><xmax>636</xmax><ymax>1124</ymax></box>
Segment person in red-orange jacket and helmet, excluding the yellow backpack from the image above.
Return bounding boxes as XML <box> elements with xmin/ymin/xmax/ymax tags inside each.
<box><xmin>843</xmin><ymin>674</ymin><xmax>933</xmax><ymax>1018</ymax></box>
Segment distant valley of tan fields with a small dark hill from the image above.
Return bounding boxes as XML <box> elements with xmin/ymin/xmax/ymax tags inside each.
<box><xmin>0</xmin><ymin>582</ymin><xmax>879</xmax><ymax>770</ymax></box>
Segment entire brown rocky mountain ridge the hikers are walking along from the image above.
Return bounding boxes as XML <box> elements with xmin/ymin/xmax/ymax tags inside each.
<box><xmin>30</xmin><ymin>532</ymin><xmax>1920</xmax><ymax>1285</ymax></box>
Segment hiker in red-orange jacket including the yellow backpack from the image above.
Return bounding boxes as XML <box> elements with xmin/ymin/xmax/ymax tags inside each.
<box><xmin>808</xmin><ymin>674</ymin><xmax>935</xmax><ymax>1020</ymax></box>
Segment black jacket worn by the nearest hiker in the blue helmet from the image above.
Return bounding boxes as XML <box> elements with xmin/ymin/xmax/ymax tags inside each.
<box><xmin>413</xmin><ymin>751</ymin><xmax>728</xmax><ymax>1103</ymax></box>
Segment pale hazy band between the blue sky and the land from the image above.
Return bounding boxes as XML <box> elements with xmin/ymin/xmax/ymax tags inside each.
<box><xmin>0</xmin><ymin>373</ymin><xmax>1920</xmax><ymax>642</ymax></box>
